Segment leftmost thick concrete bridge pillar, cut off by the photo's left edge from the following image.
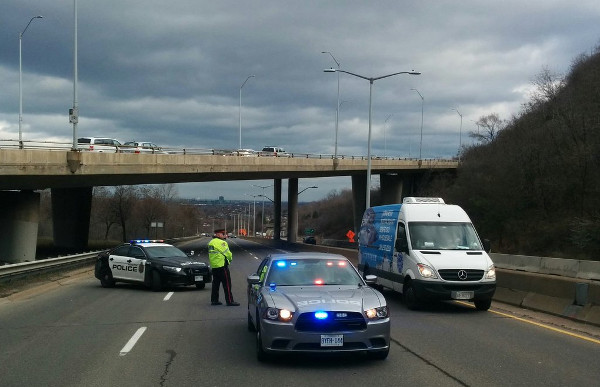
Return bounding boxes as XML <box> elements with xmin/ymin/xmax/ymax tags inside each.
<box><xmin>0</xmin><ymin>191</ymin><xmax>40</xmax><ymax>263</ymax></box>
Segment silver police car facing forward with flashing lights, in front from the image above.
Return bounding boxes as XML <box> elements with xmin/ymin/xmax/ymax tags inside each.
<box><xmin>247</xmin><ymin>252</ymin><xmax>390</xmax><ymax>361</ymax></box>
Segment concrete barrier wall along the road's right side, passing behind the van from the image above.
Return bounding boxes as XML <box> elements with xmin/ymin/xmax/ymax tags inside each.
<box><xmin>252</xmin><ymin>238</ymin><xmax>600</xmax><ymax>326</ymax></box>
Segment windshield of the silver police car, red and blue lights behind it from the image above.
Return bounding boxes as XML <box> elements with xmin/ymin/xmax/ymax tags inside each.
<box><xmin>265</xmin><ymin>259</ymin><xmax>363</xmax><ymax>286</ymax></box>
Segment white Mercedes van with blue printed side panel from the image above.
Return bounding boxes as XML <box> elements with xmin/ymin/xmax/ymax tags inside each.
<box><xmin>358</xmin><ymin>197</ymin><xmax>496</xmax><ymax>310</ymax></box>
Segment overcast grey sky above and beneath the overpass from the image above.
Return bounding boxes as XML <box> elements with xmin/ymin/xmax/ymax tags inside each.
<box><xmin>0</xmin><ymin>0</ymin><xmax>600</xmax><ymax>201</ymax></box>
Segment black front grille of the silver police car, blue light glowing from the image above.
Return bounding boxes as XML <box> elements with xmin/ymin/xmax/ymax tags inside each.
<box><xmin>296</xmin><ymin>312</ymin><xmax>367</xmax><ymax>332</ymax></box>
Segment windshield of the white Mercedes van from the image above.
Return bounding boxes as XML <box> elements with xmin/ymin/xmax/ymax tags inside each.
<box><xmin>408</xmin><ymin>222</ymin><xmax>482</xmax><ymax>250</ymax></box>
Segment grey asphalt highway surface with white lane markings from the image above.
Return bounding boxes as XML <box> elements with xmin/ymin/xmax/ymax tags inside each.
<box><xmin>0</xmin><ymin>238</ymin><xmax>600</xmax><ymax>387</ymax></box>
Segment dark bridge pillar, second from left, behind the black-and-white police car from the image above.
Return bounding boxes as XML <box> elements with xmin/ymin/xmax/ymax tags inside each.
<box><xmin>52</xmin><ymin>187</ymin><xmax>92</xmax><ymax>250</ymax></box>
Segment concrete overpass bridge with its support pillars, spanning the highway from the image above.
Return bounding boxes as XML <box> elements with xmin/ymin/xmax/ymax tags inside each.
<box><xmin>0</xmin><ymin>148</ymin><xmax>458</xmax><ymax>263</ymax></box>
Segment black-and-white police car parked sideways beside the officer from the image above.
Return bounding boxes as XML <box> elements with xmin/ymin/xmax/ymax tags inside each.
<box><xmin>94</xmin><ymin>240</ymin><xmax>212</xmax><ymax>291</ymax></box>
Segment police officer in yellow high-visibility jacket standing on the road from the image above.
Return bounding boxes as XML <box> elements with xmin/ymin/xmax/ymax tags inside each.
<box><xmin>208</xmin><ymin>229</ymin><xmax>240</xmax><ymax>306</ymax></box>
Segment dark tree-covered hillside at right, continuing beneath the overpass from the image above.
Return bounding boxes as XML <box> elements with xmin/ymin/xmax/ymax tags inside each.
<box><xmin>304</xmin><ymin>49</ymin><xmax>600</xmax><ymax>259</ymax></box>
